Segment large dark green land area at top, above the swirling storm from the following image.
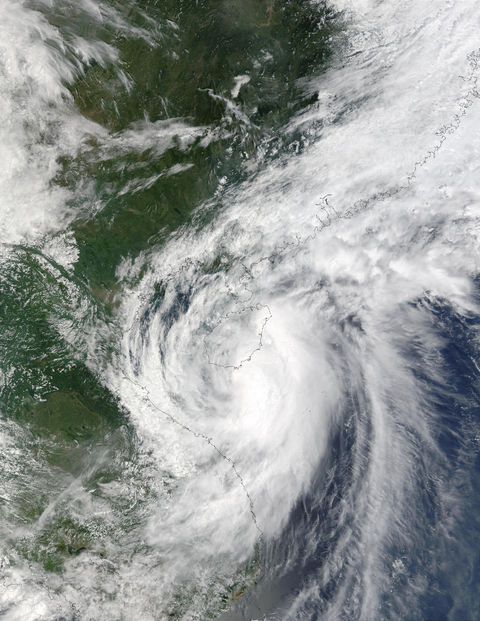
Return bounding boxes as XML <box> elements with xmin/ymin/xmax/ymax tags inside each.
<box><xmin>52</xmin><ymin>0</ymin><xmax>339</xmax><ymax>295</ymax></box>
